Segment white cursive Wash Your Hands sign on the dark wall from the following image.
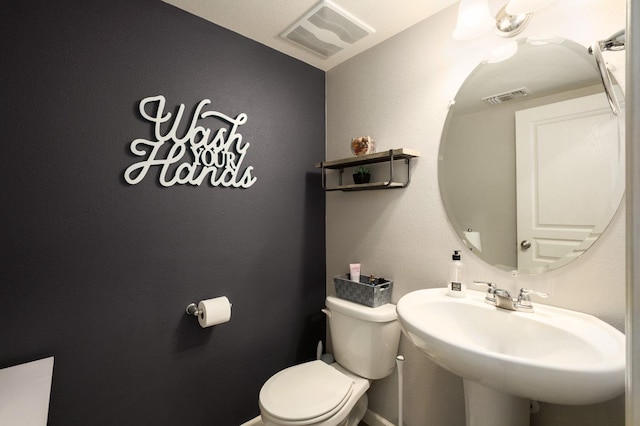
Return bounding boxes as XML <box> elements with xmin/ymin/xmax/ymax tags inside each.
<box><xmin>124</xmin><ymin>95</ymin><xmax>258</xmax><ymax>188</ymax></box>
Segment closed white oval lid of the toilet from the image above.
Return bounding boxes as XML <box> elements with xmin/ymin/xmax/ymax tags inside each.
<box><xmin>260</xmin><ymin>361</ymin><xmax>353</xmax><ymax>421</ymax></box>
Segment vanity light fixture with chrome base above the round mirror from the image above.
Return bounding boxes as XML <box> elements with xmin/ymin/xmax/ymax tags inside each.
<box><xmin>453</xmin><ymin>0</ymin><xmax>555</xmax><ymax>40</ymax></box>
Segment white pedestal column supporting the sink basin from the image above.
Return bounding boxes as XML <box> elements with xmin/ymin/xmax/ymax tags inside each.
<box><xmin>463</xmin><ymin>379</ymin><xmax>531</xmax><ymax>426</ymax></box>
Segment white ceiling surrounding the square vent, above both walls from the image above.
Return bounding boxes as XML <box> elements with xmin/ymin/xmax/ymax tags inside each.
<box><xmin>163</xmin><ymin>0</ymin><xmax>458</xmax><ymax>71</ymax></box>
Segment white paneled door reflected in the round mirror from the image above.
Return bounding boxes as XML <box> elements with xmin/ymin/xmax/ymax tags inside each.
<box><xmin>515</xmin><ymin>93</ymin><xmax>624</xmax><ymax>273</ymax></box>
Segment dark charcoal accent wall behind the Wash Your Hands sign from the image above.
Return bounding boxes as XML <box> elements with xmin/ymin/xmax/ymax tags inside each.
<box><xmin>0</xmin><ymin>0</ymin><xmax>325</xmax><ymax>426</ymax></box>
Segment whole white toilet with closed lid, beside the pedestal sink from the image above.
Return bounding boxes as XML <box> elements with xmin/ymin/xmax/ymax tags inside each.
<box><xmin>260</xmin><ymin>296</ymin><xmax>400</xmax><ymax>426</ymax></box>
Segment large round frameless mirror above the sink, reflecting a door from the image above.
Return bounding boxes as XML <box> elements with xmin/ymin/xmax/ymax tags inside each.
<box><xmin>438</xmin><ymin>37</ymin><xmax>624</xmax><ymax>274</ymax></box>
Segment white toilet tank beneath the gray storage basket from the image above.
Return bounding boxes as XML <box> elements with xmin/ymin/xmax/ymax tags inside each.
<box><xmin>326</xmin><ymin>296</ymin><xmax>400</xmax><ymax>379</ymax></box>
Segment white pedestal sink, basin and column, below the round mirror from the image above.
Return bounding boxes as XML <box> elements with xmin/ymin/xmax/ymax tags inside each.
<box><xmin>397</xmin><ymin>288</ymin><xmax>625</xmax><ymax>426</ymax></box>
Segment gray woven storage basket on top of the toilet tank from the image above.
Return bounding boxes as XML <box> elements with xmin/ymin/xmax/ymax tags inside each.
<box><xmin>333</xmin><ymin>274</ymin><xmax>393</xmax><ymax>308</ymax></box>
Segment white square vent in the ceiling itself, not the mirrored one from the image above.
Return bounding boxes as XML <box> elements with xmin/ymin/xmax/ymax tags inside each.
<box><xmin>280</xmin><ymin>0</ymin><xmax>374</xmax><ymax>58</ymax></box>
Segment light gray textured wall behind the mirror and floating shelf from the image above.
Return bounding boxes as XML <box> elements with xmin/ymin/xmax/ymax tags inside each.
<box><xmin>326</xmin><ymin>0</ymin><xmax>625</xmax><ymax>426</ymax></box>
